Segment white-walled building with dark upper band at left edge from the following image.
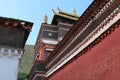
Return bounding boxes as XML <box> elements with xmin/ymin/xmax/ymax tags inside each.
<box><xmin>0</xmin><ymin>17</ymin><xmax>33</xmax><ymax>80</ymax></box>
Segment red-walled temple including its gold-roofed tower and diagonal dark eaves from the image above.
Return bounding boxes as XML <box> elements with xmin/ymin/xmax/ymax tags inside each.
<box><xmin>29</xmin><ymin>0</ymin><xmax>120</xmax><ymax>80</ymax></box>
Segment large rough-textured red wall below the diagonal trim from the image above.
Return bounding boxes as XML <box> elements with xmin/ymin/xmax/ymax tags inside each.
<box><xmin>49</xmin><ymin>26</ymin><xmax>120</xmax><ymax>80</ymax></box>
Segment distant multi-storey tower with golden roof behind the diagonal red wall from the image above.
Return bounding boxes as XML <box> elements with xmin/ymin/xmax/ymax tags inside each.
<box><xmin>31</xmin><ymin>8</ymin><xmax>79</xmax><ymax>77</ymax></box>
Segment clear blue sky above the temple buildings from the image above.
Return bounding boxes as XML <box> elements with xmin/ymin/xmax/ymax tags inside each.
<box><xmin>0</xmin><ymin>0</ymin><xmax>93</xmax><ymax>45</ymax></box>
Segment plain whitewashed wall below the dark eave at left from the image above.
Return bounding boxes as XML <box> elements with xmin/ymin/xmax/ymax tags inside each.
<box><xmin>0</xmin><ymin>57</ymin><xmax>19</xmax><ymax>80</ymax></box>
